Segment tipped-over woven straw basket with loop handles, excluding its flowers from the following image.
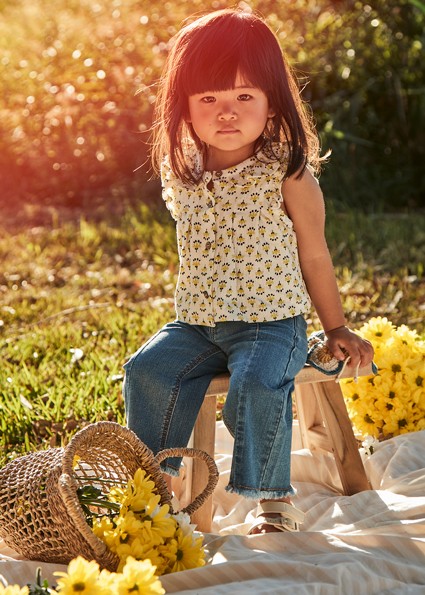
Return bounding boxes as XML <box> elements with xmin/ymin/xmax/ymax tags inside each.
<box><xmin>0</xmin><ymin>422</ymin><xmax>218</xmax><ymax>571</ymax></box>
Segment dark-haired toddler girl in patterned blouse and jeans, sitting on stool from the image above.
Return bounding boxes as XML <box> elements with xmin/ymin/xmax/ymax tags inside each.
<box><xmin>124</xmin><ymin>10</ymin><xmax>373</xmax><ymax>533</ymax></box>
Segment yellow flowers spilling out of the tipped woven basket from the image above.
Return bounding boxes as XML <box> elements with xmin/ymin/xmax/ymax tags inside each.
<box><xmin>78</xmin><ymin>469</ymin><xmax>205</xmax><ymax>576</ymax></box>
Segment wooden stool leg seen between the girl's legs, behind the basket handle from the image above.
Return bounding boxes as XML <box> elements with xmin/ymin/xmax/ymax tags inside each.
<box><xmin>191</xmin><ymin>396</ymin><xmax>217</xmax><ymax>533</ymax></box>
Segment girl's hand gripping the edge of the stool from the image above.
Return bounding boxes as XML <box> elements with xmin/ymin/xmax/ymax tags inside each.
<box><xmin>326</xmin><ymin>326</ymin><xmax>374</xmax><ymax>368</ymax></box>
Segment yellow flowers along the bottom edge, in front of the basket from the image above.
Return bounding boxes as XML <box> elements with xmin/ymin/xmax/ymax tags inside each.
<box><xmin>0</xmin><ymin>556</ymin><xmax>165</xmax><ymax>595</ymax></box>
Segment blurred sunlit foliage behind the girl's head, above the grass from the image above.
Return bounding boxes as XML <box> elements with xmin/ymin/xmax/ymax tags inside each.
<box><xmin>0</xmin><ymin>0</ymin><xmax>425</xmax><ymax>213</ymax></box>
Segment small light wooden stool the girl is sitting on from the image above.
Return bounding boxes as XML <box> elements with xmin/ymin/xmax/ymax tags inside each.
<box><xmin>191</xmin><ymin>366</ymin><xmax>373</xmax><ymax>533</ymax></box>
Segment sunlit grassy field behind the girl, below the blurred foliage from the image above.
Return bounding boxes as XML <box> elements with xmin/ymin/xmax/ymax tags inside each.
<box><xmin>0</xmin><ymin>200</ymin><xmax>425</xmax><ymax>465</ymax></box>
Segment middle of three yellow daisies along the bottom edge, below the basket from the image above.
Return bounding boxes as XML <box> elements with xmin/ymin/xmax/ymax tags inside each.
<box><xmin>53</xmin><ymin>556</ymin><xmax>104</xmax><ymax>595</ymax></box>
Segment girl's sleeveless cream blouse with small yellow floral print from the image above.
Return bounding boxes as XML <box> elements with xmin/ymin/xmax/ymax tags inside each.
<box><xmin>161</xmin><ymin>145</ymin><xmax>310</xmax><ymax>326</ymax></box>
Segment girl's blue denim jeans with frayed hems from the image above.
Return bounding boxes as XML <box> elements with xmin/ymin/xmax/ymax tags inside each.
<box><xmin>124</xmin><ymin>316</ymin><xmax>307</xmax><ymax>499</ymax></box>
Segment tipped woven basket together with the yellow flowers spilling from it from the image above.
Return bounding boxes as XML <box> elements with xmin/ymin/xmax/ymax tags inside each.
<box><xmin>0</xmin><ymin>422</ymin><xmax>218</xmax><ymax>576</ymax></box>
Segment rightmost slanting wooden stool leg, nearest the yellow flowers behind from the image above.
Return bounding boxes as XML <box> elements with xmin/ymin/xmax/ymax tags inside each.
<box><xmin>313</xmin><ymin>380</ymin><xmax>370</xmax><ymax>496</ymax></box>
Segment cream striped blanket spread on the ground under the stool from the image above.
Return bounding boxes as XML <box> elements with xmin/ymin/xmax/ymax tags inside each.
<box><xmin>0</xmin><ymin>423</ymin><xmax>425</xmax><ymax>595</ymax></box>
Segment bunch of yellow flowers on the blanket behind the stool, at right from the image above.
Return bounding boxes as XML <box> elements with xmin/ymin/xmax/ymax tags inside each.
<box><xmin>341</xmin><ymin>317</ymin><xmax>425</xmax><ymax>440</ymax></box>
